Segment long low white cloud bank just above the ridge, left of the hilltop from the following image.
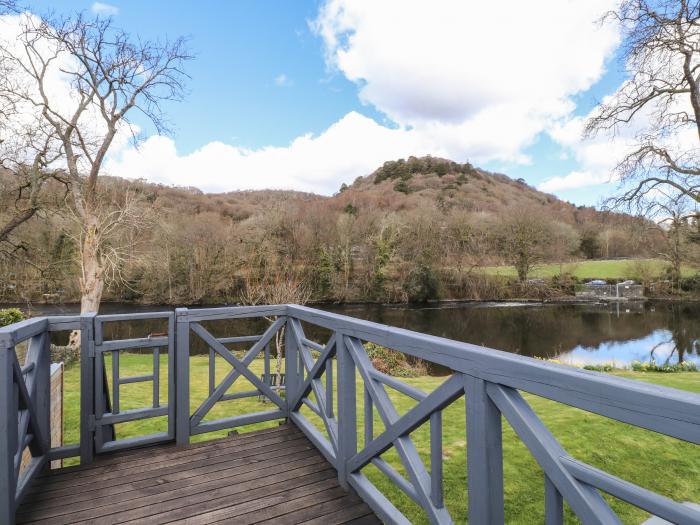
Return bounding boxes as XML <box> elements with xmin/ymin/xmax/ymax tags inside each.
<box><xmin>105</xmin><ymin>112</ymin><xmax>445</xmax><ymax>194</ymax></box>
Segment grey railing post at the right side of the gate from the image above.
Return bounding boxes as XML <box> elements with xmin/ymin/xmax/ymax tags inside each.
<box><xmin>174</xmin><ymin>308</ymin><xmax>190</xmax><ymax>446</ymax></box>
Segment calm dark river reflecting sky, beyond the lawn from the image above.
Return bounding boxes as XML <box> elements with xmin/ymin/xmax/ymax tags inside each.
<box><xmin>9</xmin><ymin>303</ymin><xmax>700</xmax><ymax>365</ymax></box>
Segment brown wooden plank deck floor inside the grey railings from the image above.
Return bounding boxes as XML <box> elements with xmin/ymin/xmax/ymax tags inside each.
<box><xmin>17</xmin><ymin>426</ymin><xmax>380</xmax><ymax>525</ymax></box>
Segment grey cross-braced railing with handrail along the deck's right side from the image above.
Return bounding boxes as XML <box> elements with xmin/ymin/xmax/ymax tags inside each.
<box><xmin>290</xmin><ymin>306</ymin><xmax>700</xmax><ymax>525</ymax></box>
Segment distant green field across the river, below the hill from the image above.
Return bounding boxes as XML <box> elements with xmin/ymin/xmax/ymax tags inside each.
<box><xmin>484</xmin><ymin>259</ymin><xmax>697</xmax><ymax>279</ymax></box>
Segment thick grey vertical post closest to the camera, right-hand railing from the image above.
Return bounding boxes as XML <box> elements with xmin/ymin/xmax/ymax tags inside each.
<box><xmin>464</xmin><ymin>375</ymin><xmax>504</xmax><ymax>525</ymax></box>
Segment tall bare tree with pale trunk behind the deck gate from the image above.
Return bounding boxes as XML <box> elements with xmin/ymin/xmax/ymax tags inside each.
<box><xmin>0</xmin><ymin>15</ymin><xmax>190</xmax><ymax>312</ymax></box>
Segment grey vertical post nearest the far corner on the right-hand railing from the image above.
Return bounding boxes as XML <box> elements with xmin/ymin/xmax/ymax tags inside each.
<box><xmin>335</xmin><ymin>332</ymin><xmax>357</xmax><ymax>490</ymax></box>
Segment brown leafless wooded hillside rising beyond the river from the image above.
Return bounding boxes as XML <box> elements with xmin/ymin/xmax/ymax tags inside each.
<box><xmin>0</xmin><ymin>157</ymin><xmax>663</xmax><ymax>304</ymax></box>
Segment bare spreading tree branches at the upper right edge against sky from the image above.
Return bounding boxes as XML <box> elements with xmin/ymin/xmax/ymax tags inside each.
<box><xmin>586</xmin><ymin>0</ymin><xmax>700</xmax><ymax>213</ymax></box>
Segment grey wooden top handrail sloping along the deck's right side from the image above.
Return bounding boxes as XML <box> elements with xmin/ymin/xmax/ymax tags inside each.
<box><xmin>287</xmin><ymin>305</ymin><xmax>700</xmax><ymax>444</ymax></box>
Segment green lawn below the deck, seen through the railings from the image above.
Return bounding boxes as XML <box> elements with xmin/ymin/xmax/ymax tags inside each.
<box><xmin>65</xmin><ymin>354</ymin><xmax>700</xmax><ymax>525</ymax></box>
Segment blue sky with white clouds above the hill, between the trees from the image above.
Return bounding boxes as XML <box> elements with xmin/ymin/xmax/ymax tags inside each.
<box><xmin>26</xmin><ymin>0</ymin><xmax>624</xmax><ymax>204</ymax></box>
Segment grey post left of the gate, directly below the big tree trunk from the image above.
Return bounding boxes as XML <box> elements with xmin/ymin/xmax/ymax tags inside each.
<box><xmin>80</xmin><ymin>312</ymin><xmax>97</xmax><ymax>465</ymax></box>
